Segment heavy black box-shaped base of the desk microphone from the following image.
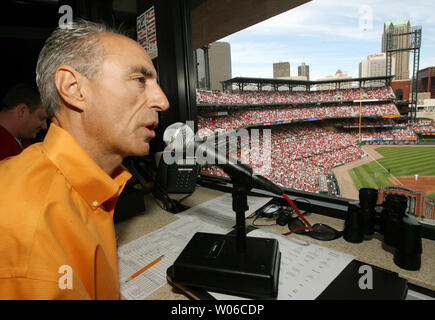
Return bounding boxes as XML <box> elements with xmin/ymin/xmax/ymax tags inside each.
<box><xmin>171</xmin><ymin>232</ymin><xmax>281</xmax><ymax>299</ymax></box>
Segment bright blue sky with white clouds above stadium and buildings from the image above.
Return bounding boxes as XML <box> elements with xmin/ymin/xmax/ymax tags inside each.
<box><xmin>219</xmin><ymin>0</ymin><xmax>435</xmax><ymax>80</ymax></box>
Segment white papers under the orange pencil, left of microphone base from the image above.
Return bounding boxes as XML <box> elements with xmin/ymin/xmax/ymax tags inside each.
<box><xmin>118</xmin><ymin>194</ymin><xmax>271</xmax><ymax>300</ymax></box>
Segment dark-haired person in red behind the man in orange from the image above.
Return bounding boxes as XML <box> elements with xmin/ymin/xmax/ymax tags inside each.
<box><xmin>0</xmin><ymin>83</ymin><xmax>47</xmax><ymax>160</ymax></box>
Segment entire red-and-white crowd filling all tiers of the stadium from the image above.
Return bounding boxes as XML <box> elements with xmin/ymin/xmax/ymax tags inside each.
<box><xmin>197</xmin><ymin>86</ymin><xmax>435</xmax><ymax>192</ymax></box>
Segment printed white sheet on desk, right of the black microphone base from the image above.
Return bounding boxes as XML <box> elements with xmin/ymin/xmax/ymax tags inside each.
<box><xmin>209</xmin><ymin>229</ymin><xmax>354</xmax><ymax>300</ymax></box>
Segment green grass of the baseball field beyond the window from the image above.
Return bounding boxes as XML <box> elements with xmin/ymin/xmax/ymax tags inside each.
<box><xmin>349</xmin><ymin>147</ymin><xmax>435</xmax><ymax>197</ymax></box>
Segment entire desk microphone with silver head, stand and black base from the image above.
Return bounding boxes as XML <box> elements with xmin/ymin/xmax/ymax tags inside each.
<box><xmin>163</xmin><ymin>123</ymin><xmax>281</xmax><ymax>298</ymax></box>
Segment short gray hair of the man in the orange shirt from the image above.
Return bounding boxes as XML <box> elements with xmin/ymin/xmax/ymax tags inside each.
<box><xmin>36</xmin><ymin>20</ymin><xmax>121</xmax><ymax>116</ymax></box>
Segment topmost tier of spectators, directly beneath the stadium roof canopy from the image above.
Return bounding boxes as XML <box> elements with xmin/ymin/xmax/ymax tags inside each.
<box><xmin>196</xmin><ymin>86</ymin><xmax>395</xmax><ymax>105</ymax></box>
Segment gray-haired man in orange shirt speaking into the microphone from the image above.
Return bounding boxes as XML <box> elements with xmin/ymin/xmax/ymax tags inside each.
<box><xmin>0</xmin><ymin>21</ymin><xmax>169</xmax><ymax>299</ymax></box>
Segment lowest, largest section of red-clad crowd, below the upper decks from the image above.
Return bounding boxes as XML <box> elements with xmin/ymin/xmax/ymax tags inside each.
<box><xmin>202</xmin><ymin>123</ymin><xmax>422</xmax><ymax>192</ymax></box>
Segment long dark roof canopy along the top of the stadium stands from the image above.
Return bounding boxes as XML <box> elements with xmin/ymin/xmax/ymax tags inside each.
<box><xmin>221</xmin><ymin>76</ymin><xmax>394</xmax><ymax>91</ymax></box>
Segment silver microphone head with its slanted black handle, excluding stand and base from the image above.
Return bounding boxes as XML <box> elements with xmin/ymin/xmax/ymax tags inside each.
<box><xmin>163</xmin><ymin>122</ymin><xmax>283</xmax><ymax>196</ymax></box>
